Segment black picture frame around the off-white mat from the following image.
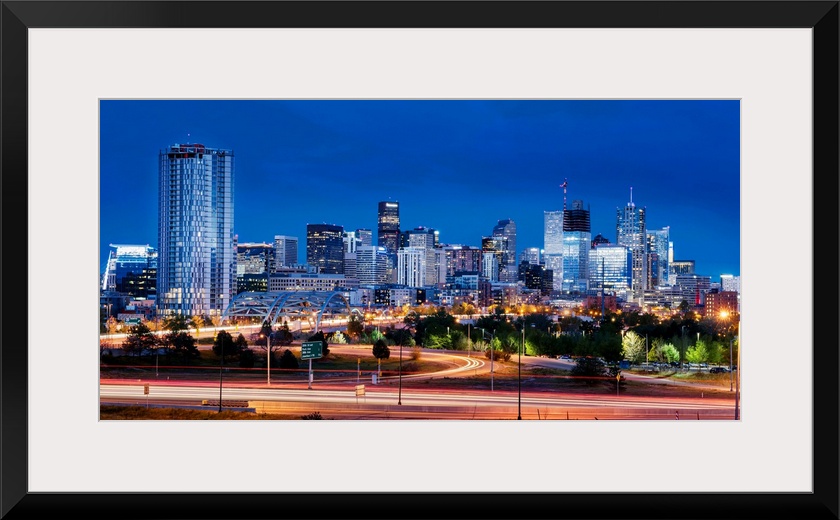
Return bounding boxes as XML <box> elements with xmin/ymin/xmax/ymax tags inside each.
<box><xmin>0</xmin><ymin>0</ymin><xmax>840</xmax><ymax>520</ymax></box>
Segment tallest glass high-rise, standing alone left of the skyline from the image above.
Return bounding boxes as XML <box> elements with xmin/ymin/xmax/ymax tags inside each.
<box><xmin>157</xmin><ymin>144</ymin><xmax>236</xmax><ymax>316</ymax></box>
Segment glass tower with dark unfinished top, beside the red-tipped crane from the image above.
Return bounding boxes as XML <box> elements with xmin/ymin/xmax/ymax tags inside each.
<box><xmin>563</xmin><ymin>200</ymin><xmax>592</xmax><ymax>294</ymax></box>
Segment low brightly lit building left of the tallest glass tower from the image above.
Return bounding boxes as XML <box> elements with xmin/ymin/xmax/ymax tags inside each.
<box><xmin>102</xmin><ymin>244</ymin><xmax>158</xmax><ymax>298</ymax></box>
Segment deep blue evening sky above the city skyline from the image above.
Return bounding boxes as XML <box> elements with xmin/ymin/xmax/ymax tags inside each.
<box><xmin>100</xmin><ymin>100</ymin><xmax>740</xmax><ymax>281</ymax></box>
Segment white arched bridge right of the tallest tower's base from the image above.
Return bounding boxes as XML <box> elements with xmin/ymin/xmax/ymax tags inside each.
<box><xmin>222</xmin><ymin>291</ymin><xmax>361</xmax><ymax>330</ymax></box>
